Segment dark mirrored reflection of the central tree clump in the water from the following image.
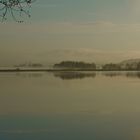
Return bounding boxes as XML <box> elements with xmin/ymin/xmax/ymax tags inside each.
<box><xmin>54</xmin><ymin>72</ymin><xmax>96</xmax><ymax>80</ymax></box>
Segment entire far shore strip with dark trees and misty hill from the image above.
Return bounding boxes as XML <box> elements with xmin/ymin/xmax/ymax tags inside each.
<box><xmin>0</xmin><ymin>59</ymin><xmax>140</xmax><ymax>72</ymax></box>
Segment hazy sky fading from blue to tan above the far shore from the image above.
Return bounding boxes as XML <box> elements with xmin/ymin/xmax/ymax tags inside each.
<box><xmin>0</xmin><ymin>0</ymin><xmax>140</xmax><ymax>66</ymax></box>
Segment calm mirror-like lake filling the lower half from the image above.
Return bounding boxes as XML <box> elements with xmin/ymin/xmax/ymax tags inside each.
<box><xmin>0</xmin><ymin>72</ymin><xmax>140</xmax><ymax>140</ymax></box>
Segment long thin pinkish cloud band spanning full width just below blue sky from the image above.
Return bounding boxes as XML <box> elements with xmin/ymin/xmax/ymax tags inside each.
<box><xmin>0</xmin><ymin>21</ymin><xmax>140</xmax><ymax>37</ymax></box>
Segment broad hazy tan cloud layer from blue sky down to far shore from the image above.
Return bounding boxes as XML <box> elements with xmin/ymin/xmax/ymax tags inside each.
<box><xmin>0</xmin><ymin>21</ymin><xmax>140</xmax><ymax>64</ymax></box>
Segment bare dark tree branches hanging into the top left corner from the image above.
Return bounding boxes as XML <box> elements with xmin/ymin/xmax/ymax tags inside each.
<box><xmin>0</xmin><ymin>0</ymin><xmax>35</xmax><ymax>22</ymax></box>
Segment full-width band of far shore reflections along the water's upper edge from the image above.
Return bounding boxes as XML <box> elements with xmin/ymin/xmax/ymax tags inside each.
<box><xmin>0</xmin><ymin>71</ymin><xmax>140</xmax><ymax>80</ymax></box>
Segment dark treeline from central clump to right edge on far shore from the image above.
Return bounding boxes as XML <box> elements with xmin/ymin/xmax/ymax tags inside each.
<box><xmin>53</xmin><ymin>61</ymin><xmax>140</xmax><ymax>71</ymax></box>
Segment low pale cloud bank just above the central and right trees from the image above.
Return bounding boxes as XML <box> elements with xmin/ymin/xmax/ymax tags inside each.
<box><xmin>38</xmin><ymin>48</ymin><xmax>140</xmax><ymax>64</ymax></box>
